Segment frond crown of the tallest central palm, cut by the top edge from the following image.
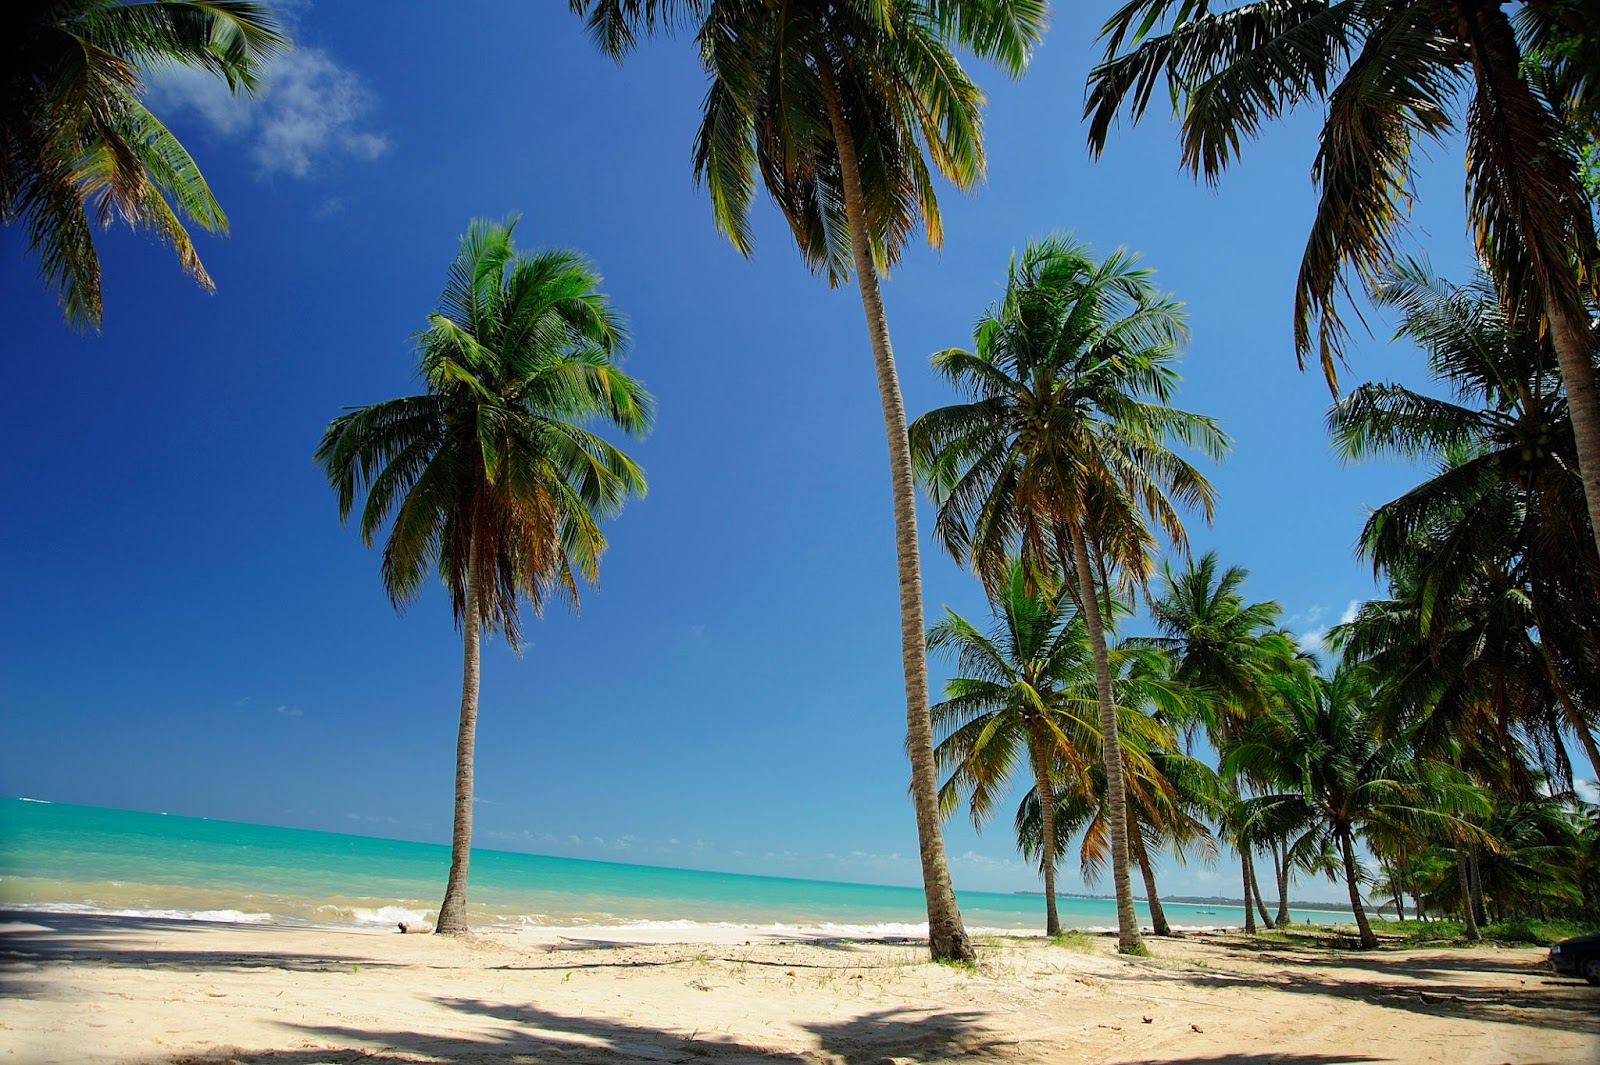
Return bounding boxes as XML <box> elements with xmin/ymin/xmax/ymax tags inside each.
<box><xmin>570</xmin><ymin>0</ymin><xmax>1046</xmax><ymax>283</ymax></box>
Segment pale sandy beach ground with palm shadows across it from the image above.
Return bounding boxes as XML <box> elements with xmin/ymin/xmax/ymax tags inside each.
<box><xmin>0</xmin><ymin>913</ymin><xmax>1600</xmax><ymax>1065</ymax></box>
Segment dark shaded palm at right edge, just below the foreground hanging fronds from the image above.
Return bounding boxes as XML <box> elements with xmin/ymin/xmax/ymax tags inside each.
<box><xmin>1328</xmin><ymin>262</ymin><xmax>1600</xmax><ymax>772</ymax></box>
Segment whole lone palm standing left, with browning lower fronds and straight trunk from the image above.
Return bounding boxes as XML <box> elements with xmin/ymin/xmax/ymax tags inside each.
<box><xmin>315</xmin><ymin>219</ymin><xmax>654</xmax><ymax>934</ymax></box>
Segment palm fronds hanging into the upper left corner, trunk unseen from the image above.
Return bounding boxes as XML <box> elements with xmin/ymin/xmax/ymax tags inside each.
<box><xmin>0</xmin><ymin>0</ymin><xmax>288</xmax><ymax>328</ymax></box>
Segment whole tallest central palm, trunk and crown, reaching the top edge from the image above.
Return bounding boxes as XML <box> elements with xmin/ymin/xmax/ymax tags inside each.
<box><xmin>570</xmin><ymin>0</ymin><xmax>1045</xmax><ymax>959</ymax></box>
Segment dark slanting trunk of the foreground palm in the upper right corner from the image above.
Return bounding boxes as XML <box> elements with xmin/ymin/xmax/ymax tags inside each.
<box><xmin>1454</xmin><ymin>0</ymin><xmax>1600</xmax><ymax>562</ymax></box>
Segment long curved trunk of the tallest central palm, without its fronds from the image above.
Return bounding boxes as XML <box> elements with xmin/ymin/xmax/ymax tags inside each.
<box><xmin>818</xmin><ymin>64</ymin><xmax>978</xmax><ymax>961</ymax></box>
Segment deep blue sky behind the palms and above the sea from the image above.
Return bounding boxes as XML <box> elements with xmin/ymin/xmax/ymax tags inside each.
<box><xmin>0</xmin><ymin>0</ymin><xmax>1497</xmax><ymax>897</ymax></box>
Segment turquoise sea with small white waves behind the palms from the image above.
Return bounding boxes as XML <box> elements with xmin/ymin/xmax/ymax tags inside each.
<box><xmin>0</xmin><ymin>798</ymin><xmax>1350</xmax><ymax>934</ymax></box>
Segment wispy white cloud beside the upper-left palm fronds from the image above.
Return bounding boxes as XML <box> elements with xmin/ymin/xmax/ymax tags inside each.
<box><xmin>150</xmin><ymin>48</ymin><xmax>389</xmax><ymax>177</ymax></box>
